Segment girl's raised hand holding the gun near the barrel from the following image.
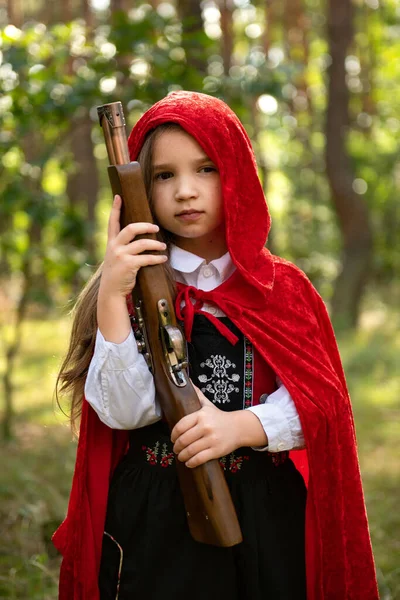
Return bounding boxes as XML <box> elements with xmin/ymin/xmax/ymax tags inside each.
<box><xmin>100</xmin><ymin>195</ymin><xmax>167</xmax><ymax>299</ymax></box>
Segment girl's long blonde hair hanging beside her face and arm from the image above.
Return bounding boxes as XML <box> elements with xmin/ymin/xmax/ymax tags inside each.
<box><xmin>55</xmin><ymin>123</ymin><xmax>181</xmax><ymax>432</ymax></box>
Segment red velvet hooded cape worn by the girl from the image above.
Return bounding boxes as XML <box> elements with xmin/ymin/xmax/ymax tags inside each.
<box><xmin>54</xmin><ymin>92</ymin><xmax>378</xmax><ymax>600</ymax></box>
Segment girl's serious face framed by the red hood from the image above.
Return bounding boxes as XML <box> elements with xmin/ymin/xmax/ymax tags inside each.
<box><xmin>152</xmin><ymin>129</ymin><xmax>226</xmax><ymax>260</ymax></box>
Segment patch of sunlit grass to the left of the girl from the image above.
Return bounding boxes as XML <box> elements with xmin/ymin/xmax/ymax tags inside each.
<box><xmin>0</xmin><ymin>320</ymin><xmax>75</xmax><ymax>600</ymax></box>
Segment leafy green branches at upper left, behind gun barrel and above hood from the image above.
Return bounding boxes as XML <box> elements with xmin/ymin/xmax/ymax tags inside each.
<box><xmin>0</xmin><ymin>5</ymin><xmax>293</xmax><ymax>308</ymax></box>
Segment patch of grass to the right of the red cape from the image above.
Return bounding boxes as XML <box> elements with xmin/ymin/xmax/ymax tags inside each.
<box><xmin>340</xmin><ymin>319</ymin><xmax>400</xmax><ymax>600</ymax></box>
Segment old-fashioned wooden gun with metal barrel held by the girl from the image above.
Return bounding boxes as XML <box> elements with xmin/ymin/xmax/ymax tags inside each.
<box><xmin>97</xmin><ymin>102</ymin><xmax>242</xmax><ymax>547</ymax></box>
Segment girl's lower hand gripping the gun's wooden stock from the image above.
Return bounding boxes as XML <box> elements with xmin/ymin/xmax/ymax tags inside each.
<box><xmin>171</xmin><ymin>386</ymin><xmax>241</xmax><ymax>467</ymax></box>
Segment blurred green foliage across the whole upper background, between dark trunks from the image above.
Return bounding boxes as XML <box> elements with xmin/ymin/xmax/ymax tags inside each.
<box><xmin>0</xmin><ymin>0</ymin><xmax>400</xmax><ymax>308</ymax></box>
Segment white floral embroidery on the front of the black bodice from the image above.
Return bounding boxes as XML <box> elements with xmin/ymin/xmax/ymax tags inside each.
<box><xmin>198</xmin><ymin>354</ymin><xmax>240</xmax><ymax>404</ymax></box>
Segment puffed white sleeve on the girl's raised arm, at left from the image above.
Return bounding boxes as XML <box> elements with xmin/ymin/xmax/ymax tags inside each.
<box><xmin>85</xmin><ymin>330</ymin><xmax>161</xmax><ymax>429</ymax></box>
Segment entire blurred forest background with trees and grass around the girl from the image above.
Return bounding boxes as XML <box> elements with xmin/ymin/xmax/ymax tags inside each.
<box><xmin>0</xmin><ymin>0</ymin><xmax>400</xmax><ymax>600</ymax></box>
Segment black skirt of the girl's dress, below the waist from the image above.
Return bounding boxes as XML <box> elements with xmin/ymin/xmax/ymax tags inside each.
<box><xmin>99</xmin><ymin>422</ymin><xmax>306</xmax><ymax>600</ymax></box>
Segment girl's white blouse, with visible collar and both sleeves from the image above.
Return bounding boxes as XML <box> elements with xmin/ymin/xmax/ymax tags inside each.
<box><xmin>85</xmin><ymin>246</ymin><xmax>304</xmax><ymax>452</ymax></box>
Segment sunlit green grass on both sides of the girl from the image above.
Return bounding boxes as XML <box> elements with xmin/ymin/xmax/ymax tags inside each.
<box><xmin>0</xmin><ymin>318</ymin><xmax>400</xmax><ymax>600</ymax></box>
